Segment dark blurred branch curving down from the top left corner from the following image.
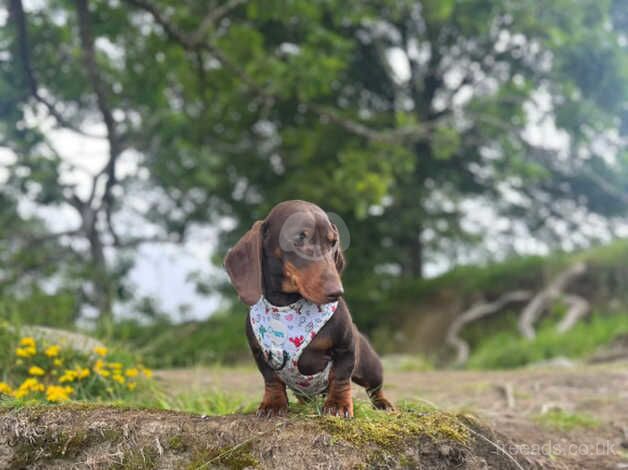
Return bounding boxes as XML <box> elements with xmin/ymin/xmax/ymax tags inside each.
<box><xmin>9</xmin><ymin>0</ymin><xmax>104</xmax><ymax>139</ymax></box>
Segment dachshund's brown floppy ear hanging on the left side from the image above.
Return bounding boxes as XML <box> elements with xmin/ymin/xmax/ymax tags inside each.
<box><xmin>225</xmin><ymin>220</ymin><xmax>264</xmax><ymax>305</ymax></box>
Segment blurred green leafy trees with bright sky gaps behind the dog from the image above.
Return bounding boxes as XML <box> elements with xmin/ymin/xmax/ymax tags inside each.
<box><xmin>0</xmin><ymin>0</ymin><xmax>628</xmax><ymax>326</ymax></box>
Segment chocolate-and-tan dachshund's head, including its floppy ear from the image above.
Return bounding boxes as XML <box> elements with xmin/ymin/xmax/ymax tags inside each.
<box><xmin>225</xmin><ymin>201</ymin><xmax>344</xmax><ymax>305</ymax></box>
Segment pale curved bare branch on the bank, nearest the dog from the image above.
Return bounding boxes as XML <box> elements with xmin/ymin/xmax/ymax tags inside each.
<box><xmin>445</xmin><ymin>290</ymin><xmax>532</xmax><ymax>365</ymax></box>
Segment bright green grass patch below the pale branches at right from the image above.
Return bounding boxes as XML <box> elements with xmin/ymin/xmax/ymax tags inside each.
<box><xmin>468</xmin><ymin>313</ymin><xmax>628</xmax><ymax>369</ymax></box>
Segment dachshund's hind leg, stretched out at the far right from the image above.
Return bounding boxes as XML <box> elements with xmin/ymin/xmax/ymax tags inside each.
<box><xmin>352</xmin><ymin>333</ymin><xmax>395</xmax><ymax>411</ymax></box>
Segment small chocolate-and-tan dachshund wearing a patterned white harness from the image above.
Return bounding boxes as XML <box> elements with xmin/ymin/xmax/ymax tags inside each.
<box><xmin>225</xmin><ymin>201</ymin><xmax>393</xmax><ymax>417</ymax></box>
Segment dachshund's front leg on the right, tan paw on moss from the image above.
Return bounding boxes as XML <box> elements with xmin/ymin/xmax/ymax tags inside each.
<box><xmin>323</xmin><ymin>340</ymin><xmax>355</xmax><ymax>418</ymax></box>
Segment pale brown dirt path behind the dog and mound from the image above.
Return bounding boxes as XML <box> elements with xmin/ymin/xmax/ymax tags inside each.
<box><xmin>157</xmin><ymin>363</ymin><xmax>628</xmax><ymax>469</ymax></box>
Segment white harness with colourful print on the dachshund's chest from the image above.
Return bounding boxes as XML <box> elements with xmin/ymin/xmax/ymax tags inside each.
<box><xmin>249</xmin><ymin>296</ymin><xmax>338</xmax><ymax>396</ymax></box>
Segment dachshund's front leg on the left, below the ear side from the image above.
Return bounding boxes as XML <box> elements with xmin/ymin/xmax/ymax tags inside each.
<box><xmin>246</xmin><ymin>316</ymin><xmax>288</xmax><ymax>417</ymax></box>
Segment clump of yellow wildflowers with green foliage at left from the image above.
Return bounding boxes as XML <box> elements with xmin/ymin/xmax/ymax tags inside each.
<box><xmin>0</xmin><ymin>337</ymin><xmax>152</xmax><ymax>403</ymax></box>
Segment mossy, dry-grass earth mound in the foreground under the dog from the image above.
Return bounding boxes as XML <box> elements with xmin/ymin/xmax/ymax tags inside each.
<box><xmin>0</xmin><ymin>406</ymin><xmax>551</xmax><ymax>469</ymax></box>
